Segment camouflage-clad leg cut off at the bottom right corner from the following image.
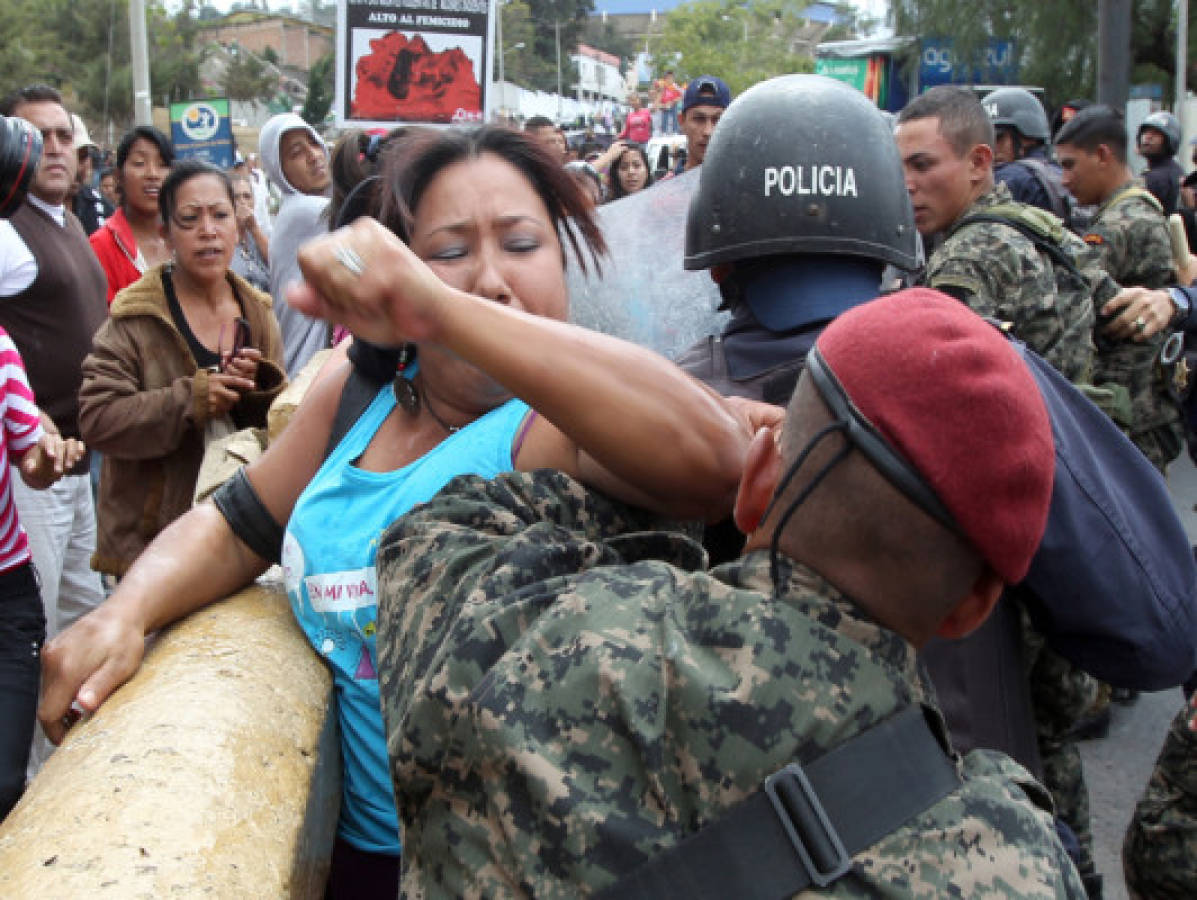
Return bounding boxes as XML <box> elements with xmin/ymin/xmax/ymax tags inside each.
<box><xmin>1123</xmin><ymin>704</ymin><xmax>1197</xmax><ymax>900</ymax></box>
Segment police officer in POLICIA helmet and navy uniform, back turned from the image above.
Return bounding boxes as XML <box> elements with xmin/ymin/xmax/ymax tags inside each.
<box><xmin>678</xmin><ymin>75</ymin><xmax>1197</xmax><ymax>899</ymax></box>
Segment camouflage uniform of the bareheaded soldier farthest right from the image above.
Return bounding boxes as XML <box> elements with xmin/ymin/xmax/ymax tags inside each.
<box><xmin>1084</xmin><ymin>182</ymin><xmax>1184</xmax><ymax>472</ymax></box>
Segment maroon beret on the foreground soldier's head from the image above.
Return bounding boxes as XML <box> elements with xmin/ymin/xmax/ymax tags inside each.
<box><xmin>816</xmin><ymin>288</ymin><xmax>1056</xmax><ymax>584</ymax></box>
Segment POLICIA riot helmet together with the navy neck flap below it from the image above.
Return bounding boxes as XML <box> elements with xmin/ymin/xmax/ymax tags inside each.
<box><xmin>685</xmin><ymin>75</ymin><xmax>918</xmax><ymax>332</ymax></box>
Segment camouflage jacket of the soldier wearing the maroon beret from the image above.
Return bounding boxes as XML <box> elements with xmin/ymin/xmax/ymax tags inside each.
<box><xmin>378</xmin><ymin>470</ymin><xmax>1083</xmax><ymax>898</ymax></box>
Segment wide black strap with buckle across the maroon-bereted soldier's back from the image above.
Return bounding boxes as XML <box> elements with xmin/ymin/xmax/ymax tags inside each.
<box><xmin>596</xmin><ymin>705</ymin><xmax>961</xmax><ymax>900</ymax></box>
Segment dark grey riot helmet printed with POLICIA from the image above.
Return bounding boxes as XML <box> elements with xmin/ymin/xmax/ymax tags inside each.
<box><xmin>685</xmin><ymin>75</ymin><xmax>917</xmax><ymax>276</ymax></box>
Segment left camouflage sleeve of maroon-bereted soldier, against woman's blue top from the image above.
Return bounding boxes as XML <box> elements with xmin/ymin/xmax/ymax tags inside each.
<box><xmin>377</xmin><ymin>469</ymin><xmax>706</xmax><ymax>766</ymax></box>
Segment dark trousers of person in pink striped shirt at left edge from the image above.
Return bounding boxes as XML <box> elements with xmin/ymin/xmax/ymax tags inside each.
<box><xmin>0</xmin><ymin>563</ymin><xmax>45</xmax><ymax>821</ymax></box>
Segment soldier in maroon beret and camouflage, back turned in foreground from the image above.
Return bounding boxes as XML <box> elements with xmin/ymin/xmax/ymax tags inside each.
<box><xmin>378</xmin><ymin>291</ymin><xmax>1083</xmax><ymax>898</ymax></box>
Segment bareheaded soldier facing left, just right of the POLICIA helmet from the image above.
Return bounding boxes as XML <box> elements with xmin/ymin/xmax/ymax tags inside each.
<box><xmin>894</xmin><ymin>80</ymin><xmax>1101</xmax><ymax>382</ymax></box>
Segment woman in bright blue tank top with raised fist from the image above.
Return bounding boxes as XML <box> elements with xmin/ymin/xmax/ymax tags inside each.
<box><xmin>43</xmin><ymin>127</ymin><xmax>774</xmax><ymax>898</ymax></box>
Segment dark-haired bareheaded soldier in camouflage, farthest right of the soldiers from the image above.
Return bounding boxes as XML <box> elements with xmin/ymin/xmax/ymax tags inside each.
<box><xmin>1056</xmin><ymin>105</ymin><xmax>1184</xmax><ymax>472</ymax></box>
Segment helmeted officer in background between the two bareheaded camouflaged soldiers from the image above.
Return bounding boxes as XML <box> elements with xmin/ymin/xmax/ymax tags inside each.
<box><xmin>982</xmin><ymin>87</ymin><xmax>1074</xmax><ymax>225</ymax></box>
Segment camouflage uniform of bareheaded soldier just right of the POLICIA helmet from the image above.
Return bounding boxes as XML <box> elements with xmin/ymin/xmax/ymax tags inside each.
<box><xmin>924</xmin><ymin>184</ymin><xmax>1094</xmax><ymax>382</ymax></box>
